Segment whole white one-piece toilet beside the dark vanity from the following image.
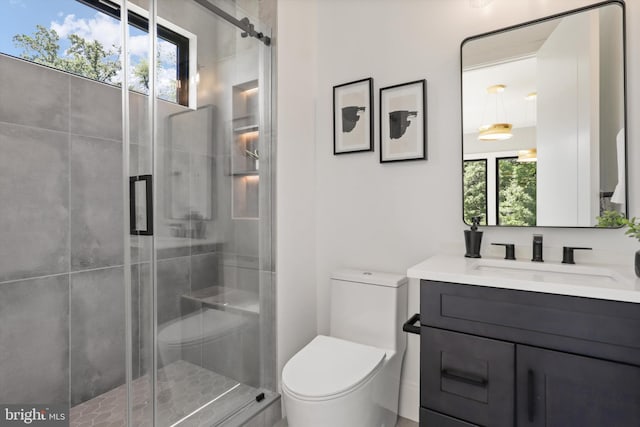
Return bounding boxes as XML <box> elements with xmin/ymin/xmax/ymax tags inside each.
<box><xmin>282</xmin><ymin>270</ymin><xmax>407</xmax><ymax>427</ymax></box>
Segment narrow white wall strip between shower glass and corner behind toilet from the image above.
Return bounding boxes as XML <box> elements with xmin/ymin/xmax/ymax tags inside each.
<box><xmin>274</xmin><ymin>0</ymin><xmax>317</xmax><ymax>392</ymax></box>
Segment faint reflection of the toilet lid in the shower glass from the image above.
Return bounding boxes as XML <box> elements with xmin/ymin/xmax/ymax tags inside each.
<box><xmin>158</xmin><ymin>308</ymin><xmax>247</xmax><ymax>366</ymax></box>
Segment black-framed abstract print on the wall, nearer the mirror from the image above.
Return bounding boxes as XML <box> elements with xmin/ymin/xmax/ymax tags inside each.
<box><xmin>380</xmin><ymin>79</ymin><xmax>427</xmax><ymax>163</ymax></box>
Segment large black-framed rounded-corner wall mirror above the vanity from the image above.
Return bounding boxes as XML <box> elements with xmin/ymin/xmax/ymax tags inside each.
<box><xmin>461</xmin><ymin>1</ymin><xmax>627</xmax><ymax>227</ymax></box>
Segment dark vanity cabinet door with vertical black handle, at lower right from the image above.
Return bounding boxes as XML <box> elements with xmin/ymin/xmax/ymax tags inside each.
<box><xmin>516</xmin><ymin>345</ymin><xmax>640</xmax><ymax>427</ymax></box>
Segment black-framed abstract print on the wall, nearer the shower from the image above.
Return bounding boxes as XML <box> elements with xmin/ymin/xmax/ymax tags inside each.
<box><xmin>333</xmin><ymin>77</ymin><xmax>374</xmax><ymax>155</ymax></box>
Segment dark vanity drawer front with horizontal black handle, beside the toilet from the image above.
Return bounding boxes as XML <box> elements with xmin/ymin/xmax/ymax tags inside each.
<box><xmin>420</xmin><ymin>327</ymin><xmax>515</xmax><ymax>427</ymax></box>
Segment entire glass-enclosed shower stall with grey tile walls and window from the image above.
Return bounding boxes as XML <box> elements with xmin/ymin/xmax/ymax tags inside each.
<box><xmin>0</xmin><ymin>0</ymin><xmax>278</xmax><ymax>427</ymax></box>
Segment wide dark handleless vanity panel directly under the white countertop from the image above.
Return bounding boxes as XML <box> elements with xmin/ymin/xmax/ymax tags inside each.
<box><xmin>420</xmin><ymin>280</ymin><xmax>640</xmax><ymax>365</ymax></box>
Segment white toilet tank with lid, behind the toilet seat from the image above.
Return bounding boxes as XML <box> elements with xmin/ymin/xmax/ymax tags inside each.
<box><xmin>330</xmin><ymin>269</ymin><xmax>408</xmax><ymax>353</ymax></box>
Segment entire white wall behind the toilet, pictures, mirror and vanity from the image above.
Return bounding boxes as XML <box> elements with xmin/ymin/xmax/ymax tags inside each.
<box><xmin>278</xmin><ymin>0</ymin><xmax>640</xmax><ymax>419</ymax></box>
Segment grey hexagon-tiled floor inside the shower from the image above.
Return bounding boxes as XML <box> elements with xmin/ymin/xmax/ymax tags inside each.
<box><xmin>71</xmin><ymin>360</ymin><xmax>259</xmax><ymax>427</ymax></box>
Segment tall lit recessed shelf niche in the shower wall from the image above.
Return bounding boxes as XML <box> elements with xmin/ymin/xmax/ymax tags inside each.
<box><xmin>230</xmin><ymin>80</ymin><xmax>260</xmax><ymax>219</ymax></box>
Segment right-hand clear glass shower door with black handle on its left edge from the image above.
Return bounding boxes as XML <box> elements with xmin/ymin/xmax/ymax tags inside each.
<box><xmin>141</xmin><ymin>0</ymin><xmax>273</xmax><ymax>426</ymax></box>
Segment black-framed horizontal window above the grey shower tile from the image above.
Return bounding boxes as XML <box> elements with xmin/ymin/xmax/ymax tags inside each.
<box><xmin>0</xmin><ymin>0</ymin><xmax>197</xmax><ymax>108</ymax></box>
